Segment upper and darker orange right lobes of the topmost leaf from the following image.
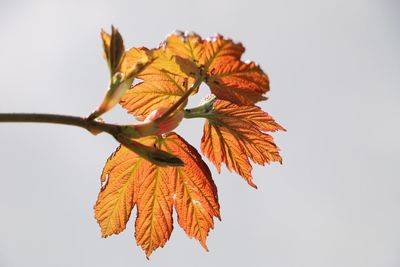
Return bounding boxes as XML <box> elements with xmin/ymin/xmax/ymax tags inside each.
<box><xmin>165</xmin><ymin>32</ymin><xmax>269</xmax><ymax>105</ymax></box>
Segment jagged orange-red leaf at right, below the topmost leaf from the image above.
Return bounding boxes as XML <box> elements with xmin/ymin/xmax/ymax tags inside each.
<box><xmin>201</xmin><ymin>100</ymin><xmax>285</xmax><ymax>188</ymax></box>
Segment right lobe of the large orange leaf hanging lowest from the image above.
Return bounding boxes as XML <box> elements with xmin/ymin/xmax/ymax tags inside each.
<box><xmin>164</xmin><ymin>133</ymin><xmax>220</xmax><ymax>250</ymax></box>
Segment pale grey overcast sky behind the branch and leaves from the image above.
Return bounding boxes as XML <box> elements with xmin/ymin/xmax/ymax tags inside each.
<box><xmin>0</xmin><ymin>0</ymin><xmax>400</xmax><ymax>267</ymax></box>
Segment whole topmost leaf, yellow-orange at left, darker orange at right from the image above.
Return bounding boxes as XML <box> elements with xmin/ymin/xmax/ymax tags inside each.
<box><xmin>121</xmin><ymin>32</ymin><xmax>269</xmax><ymax>119</ymax></box>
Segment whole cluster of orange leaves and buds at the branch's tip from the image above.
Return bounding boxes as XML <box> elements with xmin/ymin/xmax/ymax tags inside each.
<box><xmin>89</xmin><ymin>28</ymin><xmax>285</xmax><ymax>257</ymax></box>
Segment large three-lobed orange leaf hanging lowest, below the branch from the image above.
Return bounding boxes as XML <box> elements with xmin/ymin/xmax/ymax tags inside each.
<box><xmin>95</xmin><ymin>133</ymin><xmax>219</xmax><ymax>257</ymax></box>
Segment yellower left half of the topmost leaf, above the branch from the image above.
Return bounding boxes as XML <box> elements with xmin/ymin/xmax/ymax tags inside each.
<box><xmin>120</xmin><ymin>34</ymin><xmax>202</xmax><ymax>120</ymax></box>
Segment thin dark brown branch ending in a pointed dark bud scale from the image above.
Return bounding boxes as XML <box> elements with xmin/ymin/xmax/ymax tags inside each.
<box><xmin>0</xmin><ymin>113</ymin><xmax>183</xmax><ymax>166</ymax></box>
